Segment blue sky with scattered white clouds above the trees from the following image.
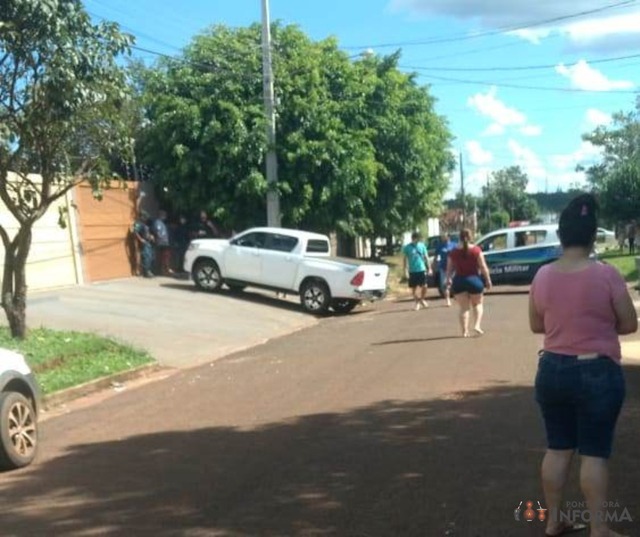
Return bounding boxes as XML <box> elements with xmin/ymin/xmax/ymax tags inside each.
<box><xmin>85</xmin><ymin>0</ymin><xmax>640</xmax><ymax>196</ymax></box>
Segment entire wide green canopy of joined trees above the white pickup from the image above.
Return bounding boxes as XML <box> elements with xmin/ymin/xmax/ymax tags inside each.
<box><xmin>137</xmin><ymin>24</ymin><xmax>453</xmax><ymax>236</ymax></box>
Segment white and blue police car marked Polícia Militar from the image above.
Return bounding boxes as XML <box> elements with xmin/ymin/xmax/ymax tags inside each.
<box><xmin>476</xmin><ymin>224</ymin><xmax>562</xmax><ymax>285</ymax></box>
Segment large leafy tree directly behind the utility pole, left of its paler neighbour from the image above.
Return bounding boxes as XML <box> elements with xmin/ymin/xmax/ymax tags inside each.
<box><xmin>139</xmin><ymin>24</ymin><xmax>376</xmax><ymax>234</ymax></box>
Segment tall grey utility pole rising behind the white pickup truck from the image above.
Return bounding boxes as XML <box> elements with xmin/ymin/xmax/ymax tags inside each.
<box><xmin>262</xmin><ymin>0</ymin><xmax>280</xmax><ymax>227</ymax></box>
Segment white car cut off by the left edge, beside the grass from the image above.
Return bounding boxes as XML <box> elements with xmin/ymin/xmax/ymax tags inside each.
<box><xmin>0</xmin><ymin>349</ymin><xmax>41</xmax><ymax>470</ymax></box>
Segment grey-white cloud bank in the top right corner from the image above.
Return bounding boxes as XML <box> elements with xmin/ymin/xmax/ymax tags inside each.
<box><xmin>390</xmin><ymin>0</ymin><xmax>640</xmax><ymax>50</ymax></box>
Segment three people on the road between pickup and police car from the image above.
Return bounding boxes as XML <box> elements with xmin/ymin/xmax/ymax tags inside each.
<box><xmin>403</xmin><ymin>229</ymin><xmax>492</xmax><ymax>337</ymax></box>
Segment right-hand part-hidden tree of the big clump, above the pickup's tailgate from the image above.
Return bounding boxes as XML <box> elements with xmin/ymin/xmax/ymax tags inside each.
<box><xmin>356</xmin><ymin>53</ymin><xmax>454</xmax><ymax>241</ymax></box>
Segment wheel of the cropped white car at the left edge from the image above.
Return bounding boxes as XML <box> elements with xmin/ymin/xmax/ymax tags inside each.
<box><xmin>0</xmin><ymin>392</ymin><xmax>38</xmax><ymax>470</ymax></box>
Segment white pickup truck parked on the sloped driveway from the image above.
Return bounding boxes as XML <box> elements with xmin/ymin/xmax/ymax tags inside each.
<box><xmin>184</xmin><ymin>227</ymin><xmax>389</xmax><ymax>314</ymax></box>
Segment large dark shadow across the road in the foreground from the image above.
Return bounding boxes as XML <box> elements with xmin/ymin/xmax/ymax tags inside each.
<box><xmin>0</xmin><ymin>368</ymin><xmax>640</xmax><ymax>537</ymax></box>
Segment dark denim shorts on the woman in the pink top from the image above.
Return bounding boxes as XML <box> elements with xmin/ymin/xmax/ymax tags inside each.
<box><xmin>535</xmin><ymin>351</ymin><xmax>625</xmax><ymax>459</ymax></box>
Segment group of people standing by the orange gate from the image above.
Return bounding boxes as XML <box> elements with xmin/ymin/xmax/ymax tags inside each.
<box><xmin>133</xmin><ymin>210</ymin><xmax>222</xmax><ymax>278</ymax></box>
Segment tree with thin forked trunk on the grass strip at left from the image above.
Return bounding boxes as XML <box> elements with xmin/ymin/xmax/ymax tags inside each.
<box><xmin>0</xmin><ymin>0</ymin><xmax>131</xmax><ymax>338</ymax></box>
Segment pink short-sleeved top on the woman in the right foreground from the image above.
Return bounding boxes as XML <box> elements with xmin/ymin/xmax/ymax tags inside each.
<box><xmin>531</xmin><ymin>263</ymin><xmax>628</xmax><ymax>363</ymax></box>
